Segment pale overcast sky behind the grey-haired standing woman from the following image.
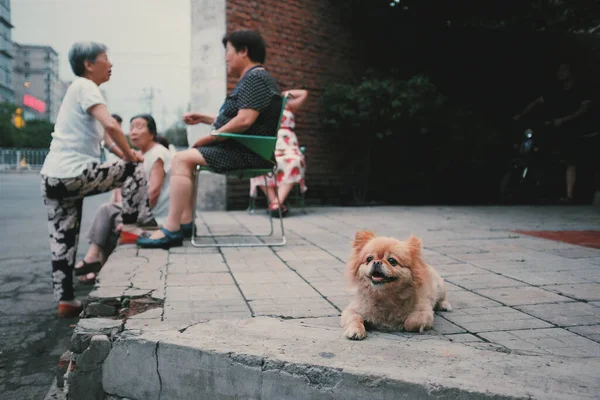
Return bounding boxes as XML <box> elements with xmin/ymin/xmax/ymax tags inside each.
<box><xmin>11</xmin><ymin>0</ymin><xmax>191</xmax><ymax>133</ymax></box>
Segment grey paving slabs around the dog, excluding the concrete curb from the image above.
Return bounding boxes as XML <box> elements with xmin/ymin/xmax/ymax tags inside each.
<box><xmin>91</xmin><ymin>207</ymin><xmax>600</xmax><ymax>357</ymax></box>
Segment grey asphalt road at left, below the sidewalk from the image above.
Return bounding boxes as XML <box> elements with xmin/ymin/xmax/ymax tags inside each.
<box><xmin>0</xmin><ymin>173</ymin><xmax>109</xmax><ymax>400</ymax></box>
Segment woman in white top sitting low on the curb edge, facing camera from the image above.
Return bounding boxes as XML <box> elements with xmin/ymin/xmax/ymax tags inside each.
<box><xmin>75</xmin><ymin>114</ymin><xmax>173</xmax><ymax>283</ymax></box>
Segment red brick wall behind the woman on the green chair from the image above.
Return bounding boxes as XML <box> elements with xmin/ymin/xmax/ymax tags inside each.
<box><xmin>227</xmin><ymin>0</ymin><xmax>363</xmax><ymax>209</ymax></box>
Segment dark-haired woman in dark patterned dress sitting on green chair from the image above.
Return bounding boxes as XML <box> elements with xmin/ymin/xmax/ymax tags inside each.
<box><xmin>137</xmin><ymin>30</ymin><xmax>281</xmax><ymax>249</ymax></box>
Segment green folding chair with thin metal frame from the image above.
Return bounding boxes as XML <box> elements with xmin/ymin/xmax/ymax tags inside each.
<box><xmin>192</xmin><ymin>94</ymin><xmax>287</xmax><ymax>247</ymax></box>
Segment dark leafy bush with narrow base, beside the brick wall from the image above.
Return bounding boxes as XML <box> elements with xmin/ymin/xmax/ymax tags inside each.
<box><xmin>322</xmin><ymin>72</ymin><xmax>444</xmax><ymax>204</ymax></box>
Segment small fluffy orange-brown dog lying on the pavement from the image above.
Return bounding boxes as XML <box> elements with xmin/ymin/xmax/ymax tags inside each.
<box><xmin>341</xmin><ymin>231</ymin><xmax>451</xmax><ymax>340</ymax></box>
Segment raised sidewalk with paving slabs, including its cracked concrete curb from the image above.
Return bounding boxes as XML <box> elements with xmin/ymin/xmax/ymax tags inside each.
<box><xmin>67</xmin><ymin>207</ymin><xmax>600</xmax><ymax>399</ymax></box>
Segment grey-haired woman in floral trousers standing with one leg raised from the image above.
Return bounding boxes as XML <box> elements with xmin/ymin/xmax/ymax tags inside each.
<box><xmin>41</xmin><ymin>42</ymin><xmax>148</xmax><ymax>318</ymax></box>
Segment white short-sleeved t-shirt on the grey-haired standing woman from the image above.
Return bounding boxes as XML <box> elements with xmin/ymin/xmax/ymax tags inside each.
<box><xmin>41</xmin><ymin>77</ymin><xmax>106</xmax><ymax>178</ymax></box>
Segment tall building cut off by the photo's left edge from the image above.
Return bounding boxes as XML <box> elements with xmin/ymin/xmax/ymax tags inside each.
<box><xmin>0</xmin><ymin>0</ymin><xmax>15</xmax><ymax>103</ymax></box>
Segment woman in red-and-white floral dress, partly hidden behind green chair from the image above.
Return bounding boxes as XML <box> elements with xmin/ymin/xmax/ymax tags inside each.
<box><xmin>250</xmin><ymin>89</ymin><xmax>308</xmax><ymax>217</ymax></box>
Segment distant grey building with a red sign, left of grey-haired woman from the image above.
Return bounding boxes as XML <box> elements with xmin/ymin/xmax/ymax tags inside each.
<box><xmin>13</xmin><ymin>43</ymin><xmax>62</xmax><ymax>122</ymax></box>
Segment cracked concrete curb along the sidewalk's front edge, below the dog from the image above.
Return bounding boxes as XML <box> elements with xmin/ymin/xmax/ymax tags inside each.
<box><xmin>95</xmin><ymin>317</ymin><xmax>600</xmax><ymax>400</ymax></box>
